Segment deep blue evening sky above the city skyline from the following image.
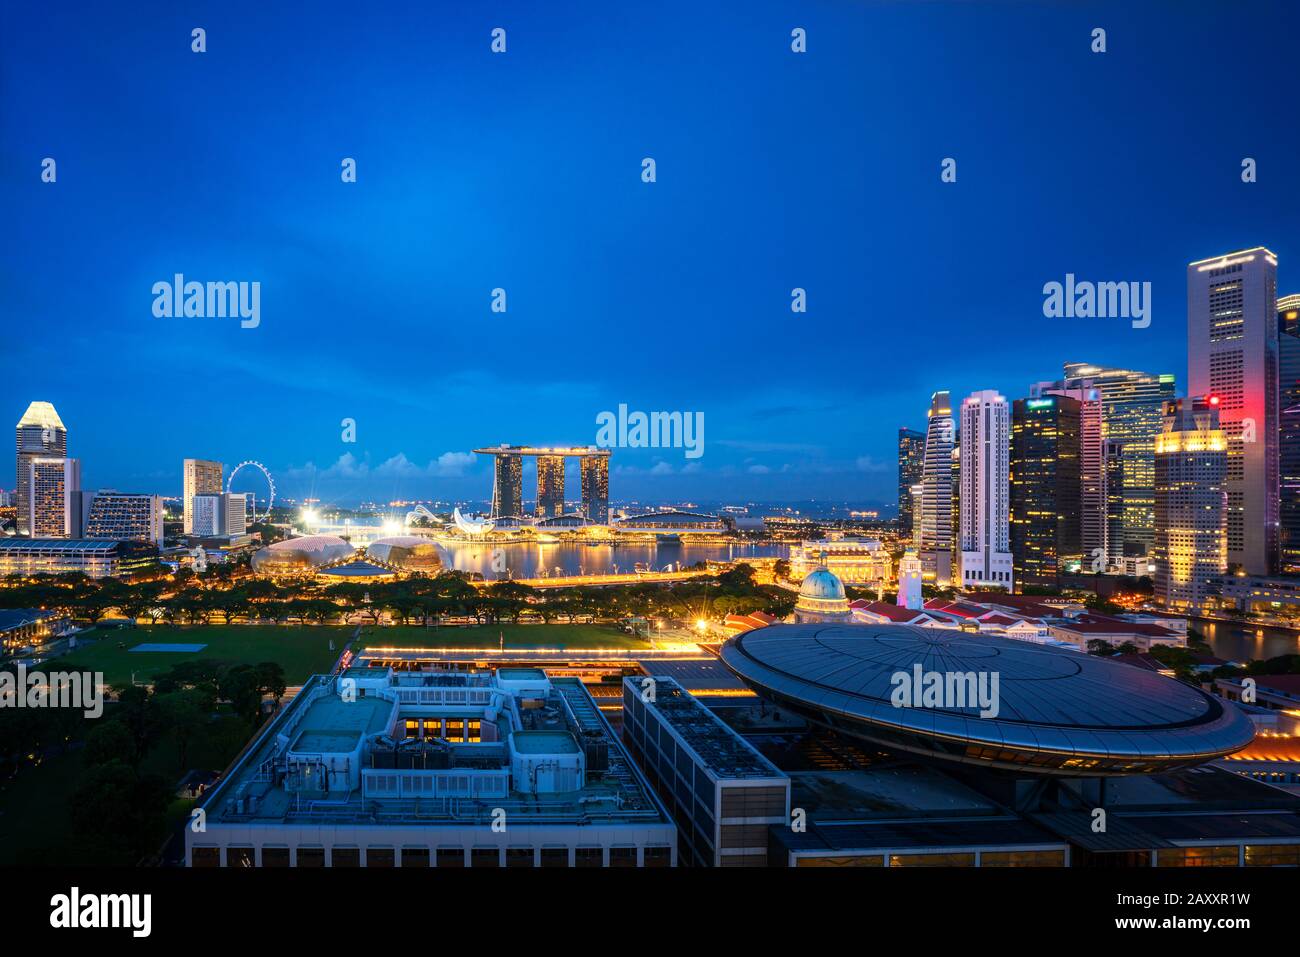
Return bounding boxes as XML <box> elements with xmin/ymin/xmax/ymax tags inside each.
<box><xmin>0</xmin><ymin>0</ymin><xmax>1300</xmax><ymax>505</ymax></box>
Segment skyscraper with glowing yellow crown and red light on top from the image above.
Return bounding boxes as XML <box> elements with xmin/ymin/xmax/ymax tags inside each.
<box><xmin>1156</xmin><ymin>395</ymin><xmax>1229</xmax><ymax>609</ymax></box>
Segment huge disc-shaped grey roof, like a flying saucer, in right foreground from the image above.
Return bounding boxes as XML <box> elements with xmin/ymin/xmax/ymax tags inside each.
<box><xmin>722</xmin><ymin>624</ymin><xmax>1255</xmax><ymax>776</ymax></box>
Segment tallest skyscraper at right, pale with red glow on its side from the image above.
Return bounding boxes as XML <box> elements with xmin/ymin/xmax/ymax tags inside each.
<box><xmin>1187</xmin><ymin>246</ymin><xmax>1278</xmax><ymax>575</ymax></box>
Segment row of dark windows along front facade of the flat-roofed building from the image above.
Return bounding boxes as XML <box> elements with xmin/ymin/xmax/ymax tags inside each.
<box><xmin>197</xmin><ymin>844</ymin><xmax>672</xmax><ymax>867</ymax></box>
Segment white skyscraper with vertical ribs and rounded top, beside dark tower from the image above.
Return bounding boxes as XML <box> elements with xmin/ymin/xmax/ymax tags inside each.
<box><xmin>958</xmin><ymin>390</ymin><xmax>1013</xmax><ymax>592</ymax></box>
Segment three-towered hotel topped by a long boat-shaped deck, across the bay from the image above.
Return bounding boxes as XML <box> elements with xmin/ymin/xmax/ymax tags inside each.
<box><xmin>475</xmin><ymin>445</ymin><xmax>610</xmax><ymax>525</ymax></box>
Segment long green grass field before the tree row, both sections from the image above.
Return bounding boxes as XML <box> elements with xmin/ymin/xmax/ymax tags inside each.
<box><xmin>55</xmin><ymin>624</ymin><xmax>649</xmax><ymax>685</ymax></box>
